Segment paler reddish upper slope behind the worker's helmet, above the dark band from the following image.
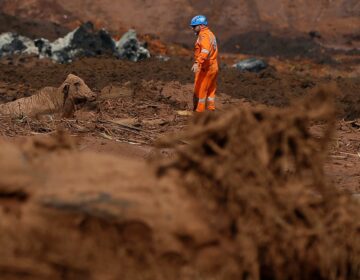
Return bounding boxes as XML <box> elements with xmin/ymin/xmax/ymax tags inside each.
<box><xmin>52</xmin><ymin>0</ymin><xmax>360</xmax><ymax>47</ymax></box>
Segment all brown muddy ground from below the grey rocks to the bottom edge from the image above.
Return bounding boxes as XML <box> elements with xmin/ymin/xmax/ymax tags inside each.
<box><xmin>0</xmin><ymin>50</ymin><xmax>360</xmax><ymax>280</ymax></box>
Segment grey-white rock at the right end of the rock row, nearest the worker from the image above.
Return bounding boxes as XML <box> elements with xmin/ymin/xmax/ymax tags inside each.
<box><xmin>116</xmin><ymin>29</ymin><xmax>150</xmax><ymax>62</ymax></box>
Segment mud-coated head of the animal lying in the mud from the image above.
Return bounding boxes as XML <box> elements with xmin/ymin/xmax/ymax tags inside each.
<box><xmin>60</xmin><ymin>74</ymin><xmax>96</xmax><ymax>117</ymax></box>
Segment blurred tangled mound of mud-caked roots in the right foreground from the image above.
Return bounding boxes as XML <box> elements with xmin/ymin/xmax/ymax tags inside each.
<box><xmin>158</xmin><ymin>86</ymin><xmax>360</xmax><ymax>279</ymax></box>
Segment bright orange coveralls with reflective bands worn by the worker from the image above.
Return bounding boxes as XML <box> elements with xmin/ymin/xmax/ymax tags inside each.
<box><xmin>194</xmin><ymin>27</ymin><xmax>219</xmax><ymax>112</ymax></box>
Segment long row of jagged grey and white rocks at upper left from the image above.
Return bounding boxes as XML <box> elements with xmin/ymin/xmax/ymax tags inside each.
<box><xmin>0</xmin><ymin>22</ymin><xmax>150</xmax><ymax>63</ymax></box>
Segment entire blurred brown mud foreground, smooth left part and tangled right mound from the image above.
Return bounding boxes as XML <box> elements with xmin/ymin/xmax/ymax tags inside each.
<box><xmin>0</xmin><ymin>84</ymin><xmax>360</xmax><ymax>280</ymax></box>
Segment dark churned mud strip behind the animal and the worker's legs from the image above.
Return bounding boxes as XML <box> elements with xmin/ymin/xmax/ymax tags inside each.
<box><xmin>0</xmin><ymin>56</ymin><xmax>360</xmax><ymax>115</ymax></box>
